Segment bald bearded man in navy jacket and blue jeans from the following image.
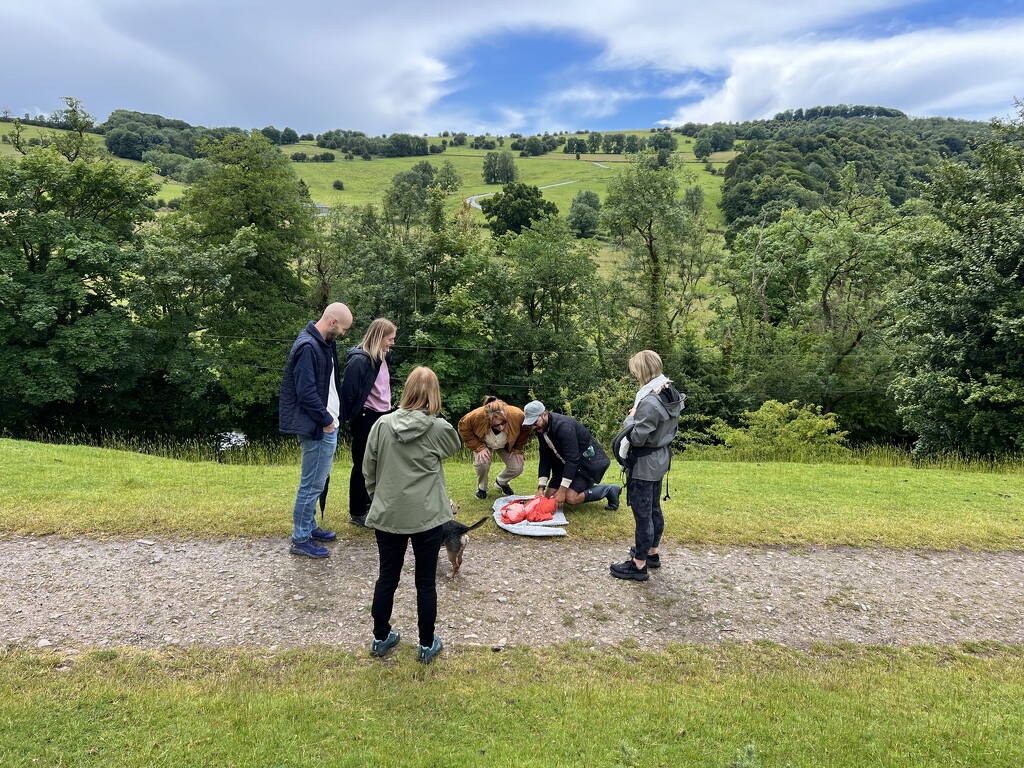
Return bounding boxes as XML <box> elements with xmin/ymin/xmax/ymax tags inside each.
<box><xmin>279</xmin><ymin>303</ymin><xmax>352</xmax><ymax>558</ymax></box>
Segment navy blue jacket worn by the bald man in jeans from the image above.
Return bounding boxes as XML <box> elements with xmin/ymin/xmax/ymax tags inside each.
<box><xmin>278</xmin><ymin>321</ymin><xmax>341</xmax><ymax>440</ymax></box>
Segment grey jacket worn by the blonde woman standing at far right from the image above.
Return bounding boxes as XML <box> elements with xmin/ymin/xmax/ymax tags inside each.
<box><xmin>612</xmin><ymin>384</ymin><xmax>686</xmax><ymax>481</ymax></box>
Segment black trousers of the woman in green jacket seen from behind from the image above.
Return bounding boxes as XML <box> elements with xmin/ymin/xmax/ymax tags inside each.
<box><xmin>370</xmin><ymin>525</ymin><xmax>441</xmax><ymax>647</ymax></box>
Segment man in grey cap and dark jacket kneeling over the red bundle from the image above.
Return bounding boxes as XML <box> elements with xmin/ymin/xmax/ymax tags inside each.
<box><xmin>522</xmin><ymin>400</ymin><xmax>623</xmax><ymax>509</ymax></box>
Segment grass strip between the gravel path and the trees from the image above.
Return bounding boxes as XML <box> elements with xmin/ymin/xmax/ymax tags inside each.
<box><xmin>0</xmin><ymin>439</ymin><xmax>1024</xmax><ymax>550</ymax></box>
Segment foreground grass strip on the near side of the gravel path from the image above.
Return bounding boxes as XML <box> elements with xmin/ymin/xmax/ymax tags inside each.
<box><xmin>0</xmin><ymin>645</ymin><xmax>1024</xmax><ymax>768</ymax></box>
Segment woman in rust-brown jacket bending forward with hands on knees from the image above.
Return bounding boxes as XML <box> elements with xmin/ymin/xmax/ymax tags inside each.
<box><xmin>459</xmin><ymin>395</ymin><xmax>530</xmax><ymax>499</ymax></box>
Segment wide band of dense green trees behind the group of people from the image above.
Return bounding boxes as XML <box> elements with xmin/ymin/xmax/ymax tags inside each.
<box><xmin>0</xmin><ymin>97</ymin><xmax>1024</xmax><ymax>456</ymax></box>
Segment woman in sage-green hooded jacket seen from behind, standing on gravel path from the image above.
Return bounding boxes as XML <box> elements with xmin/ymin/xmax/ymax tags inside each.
<box><xmin>362</xmin><ymin>367</ymin><xmax>462</xmax><ymax>664</ymax></box>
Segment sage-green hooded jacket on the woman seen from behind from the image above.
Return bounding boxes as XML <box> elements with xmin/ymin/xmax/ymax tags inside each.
<box><xmin>362</xmin><ymin>408</ymin><xmax>462</xmax><ymax>534</ymax></box>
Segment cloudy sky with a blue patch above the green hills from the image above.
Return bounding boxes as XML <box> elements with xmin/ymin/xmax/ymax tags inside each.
<box><xmin>0</xmin><ymin>0</ymin><xmax>1024</xmax><ymax>135</ymax></box>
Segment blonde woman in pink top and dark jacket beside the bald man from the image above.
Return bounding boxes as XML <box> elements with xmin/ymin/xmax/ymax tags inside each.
<box><xmin>341</xmin><ymin>317</ymin><xmax>398</xmax><ymax>527</ymax></box>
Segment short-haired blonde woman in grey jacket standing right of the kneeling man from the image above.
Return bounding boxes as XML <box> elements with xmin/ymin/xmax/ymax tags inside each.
<box><xmin>611</xmin><ymin>349</ymin><xmax>686</xmax><ymax>582</ymax></box>
